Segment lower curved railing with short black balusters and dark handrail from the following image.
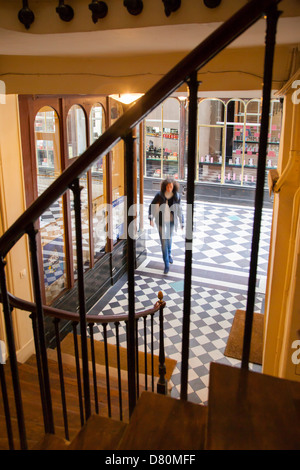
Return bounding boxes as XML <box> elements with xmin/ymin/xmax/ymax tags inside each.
<box><xmin>0</xmin><ymin>292</ymin><xmax>167</xmax><ymax>449</ymax></box>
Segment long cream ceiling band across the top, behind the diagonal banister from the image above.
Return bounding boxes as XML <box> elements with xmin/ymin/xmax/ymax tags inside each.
<box><xmin>0</xmin><ymin>17</ymin><xmax>300</xmax><ymax>56</ymax></box>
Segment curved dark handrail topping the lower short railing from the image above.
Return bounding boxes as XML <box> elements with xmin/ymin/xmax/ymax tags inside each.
<box><xmin>0</xmin><ymin>292</ymin><xmax>166</xmax><ymax>324</ymax></box>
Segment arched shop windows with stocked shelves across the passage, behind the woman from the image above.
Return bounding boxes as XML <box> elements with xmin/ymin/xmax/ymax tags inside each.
<box><xmin>144</xmin><ymin>98</ymin><xmax>282</xmax><ymax>187</ymax></box>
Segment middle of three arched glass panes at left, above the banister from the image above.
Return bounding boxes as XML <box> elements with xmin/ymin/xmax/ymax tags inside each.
<box><xmin>67</xmin><ymin>104</ymin><xmax>87</xmax><ymax>158</ymax></box>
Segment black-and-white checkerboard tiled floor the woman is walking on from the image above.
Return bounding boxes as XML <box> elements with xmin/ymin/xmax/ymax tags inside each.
<box><xmin>89</xmin><ymin>198</ymin><xmax>272</xmax><ymax>403</ymax></box>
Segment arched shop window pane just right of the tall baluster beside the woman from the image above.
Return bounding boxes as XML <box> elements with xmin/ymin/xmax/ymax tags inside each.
<box><xmin>196</xmin><ymin>99</ymin><xmax>225</xmax><ymax>183</ymax></box>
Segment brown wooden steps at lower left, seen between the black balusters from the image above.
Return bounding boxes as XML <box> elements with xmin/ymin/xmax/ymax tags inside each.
<box><xmin>0</xmin><ymin>356</ymin><xmax>129</xmax><ymax>450</ymax></box>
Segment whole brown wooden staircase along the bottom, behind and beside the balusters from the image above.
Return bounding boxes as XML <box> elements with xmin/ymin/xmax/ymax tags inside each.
<box><xmin>0</xmin><ymin>350</ymin><xmax>300</xmax><ymax>451</ymax></box>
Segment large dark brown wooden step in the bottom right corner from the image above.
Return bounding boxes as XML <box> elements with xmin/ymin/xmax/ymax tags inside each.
<box><xmin>206</xmin><ymin>363</ymin><xmax>300</xmax><ymax>450</ymax></box>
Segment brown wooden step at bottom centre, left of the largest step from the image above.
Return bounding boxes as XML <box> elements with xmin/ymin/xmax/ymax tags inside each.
<box><xmin>118</xmin><ymin>392</ymin><xmax>207</xmax><ymax>450</ymax></box>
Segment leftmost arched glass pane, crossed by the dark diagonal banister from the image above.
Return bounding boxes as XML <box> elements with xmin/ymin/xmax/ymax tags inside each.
<box><xmin>35</xmin><ymin>106</ymin><xmax>66</xmax><ymax>304</ymax></box>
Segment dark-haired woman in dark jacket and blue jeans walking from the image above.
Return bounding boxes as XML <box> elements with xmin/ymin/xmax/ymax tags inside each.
<box><xmin>149</xmin><ymin>178</ymin><xmax>184</xmax><ymax>274</ymax></box>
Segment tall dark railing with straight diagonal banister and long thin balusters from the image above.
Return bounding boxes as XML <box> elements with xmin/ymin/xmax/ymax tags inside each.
<box><xmin>0</xmin><ymin>0</ymin><xmax>280</xmax><ymax>448</ymax></box>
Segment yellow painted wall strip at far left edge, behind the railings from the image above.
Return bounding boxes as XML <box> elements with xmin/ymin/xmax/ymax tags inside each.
<box><xmin>0</xmin><ymin>95</ymin><xmax>33</xmax><ymax>361</ymax></box>
